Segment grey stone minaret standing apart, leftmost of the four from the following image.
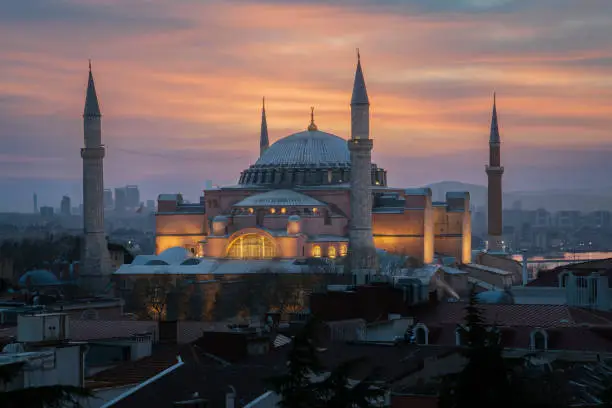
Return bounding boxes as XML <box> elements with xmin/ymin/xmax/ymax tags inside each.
<box><xmin>79</xmin><ymin>61</ymin><xmax>112</xmax><ymax>293</ymax></box>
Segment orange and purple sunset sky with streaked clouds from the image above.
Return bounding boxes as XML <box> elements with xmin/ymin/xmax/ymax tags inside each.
<box><xmin>0</xmin><ymin>0</ymin><xmax>612</xmax><ymax>211</ymax></box>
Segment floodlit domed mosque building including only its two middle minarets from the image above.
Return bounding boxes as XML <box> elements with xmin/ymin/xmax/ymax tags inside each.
<box><xmin>156</xmin><ymin>55</ymin><xmax>471</xmax><ymax>264</ymax></box>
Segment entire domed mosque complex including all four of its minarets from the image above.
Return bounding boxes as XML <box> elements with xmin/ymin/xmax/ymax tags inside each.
<box><xmin>81</xmin><ymin>51</ymin><xmax>503</xmax><ymax>300</ymax></box>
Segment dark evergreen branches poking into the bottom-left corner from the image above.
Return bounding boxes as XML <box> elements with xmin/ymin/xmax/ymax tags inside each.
<box><xmin>0</xmin><ymin>363</ymin><xmax>92</xmax><ymax>408</ymax></box>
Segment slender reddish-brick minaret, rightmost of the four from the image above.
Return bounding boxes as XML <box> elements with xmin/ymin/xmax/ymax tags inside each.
<box><xmin>486</xmin><ymin>93</ymin><xmax>504</xmax><ymax>251</ymax></box>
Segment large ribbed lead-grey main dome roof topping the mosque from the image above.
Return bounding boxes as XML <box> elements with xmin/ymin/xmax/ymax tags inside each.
<box><xmin>254</xmin><ymin>130</ymin><xmax>351</xmax><ymax>168</ymax></box>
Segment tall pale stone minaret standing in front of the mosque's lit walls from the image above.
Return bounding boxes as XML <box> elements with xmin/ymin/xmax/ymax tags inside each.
<box><xmin>348</xmin><ymin>50</ymin><xmax>377</xmax><ymax>283</ymax></box>
